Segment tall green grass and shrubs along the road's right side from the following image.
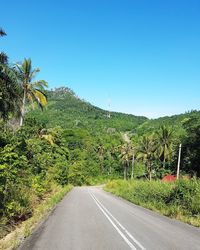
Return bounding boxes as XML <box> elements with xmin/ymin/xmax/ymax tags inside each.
<box><xmin>104</xmin><ymin>179</ymin><xmax>200</xmax><ymax>226</ymax></box>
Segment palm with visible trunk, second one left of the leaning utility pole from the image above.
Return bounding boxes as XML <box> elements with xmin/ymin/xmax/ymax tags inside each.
<box><xmin>137</xmin><ymin>135</ymin><xmax>157</xmax><ymax>180</ymax></box>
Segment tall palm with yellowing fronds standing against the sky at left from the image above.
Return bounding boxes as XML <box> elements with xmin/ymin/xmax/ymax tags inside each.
<box><xmin>15</xmin><ymin>58</ymin><xmax>48</xmax><ymax>126</ymax></box>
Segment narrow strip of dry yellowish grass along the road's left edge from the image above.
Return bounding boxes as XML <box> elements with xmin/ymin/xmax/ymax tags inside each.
<box><xmin>0</xmin><ymin>185</ymin><xmax>73</xmax><ymax>250</ymax></box>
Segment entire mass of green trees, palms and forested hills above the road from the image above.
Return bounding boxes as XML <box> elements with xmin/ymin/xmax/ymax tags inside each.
<box><xmin>0</xmin><ymin>27</ymin><xmax>200</xmax><ymax>238</ymax></box>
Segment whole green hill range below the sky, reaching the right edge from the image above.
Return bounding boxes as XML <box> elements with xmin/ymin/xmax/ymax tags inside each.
<box><xmin>27</xmin><ymin>87</ymin><xmax>200</xmax><ymax>135</ymax></box>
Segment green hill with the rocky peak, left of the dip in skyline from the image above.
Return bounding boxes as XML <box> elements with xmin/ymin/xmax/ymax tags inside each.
<box><xmin>27</xmin><ymin>87</ymin><xmax>148</xmax><ymax>132</ymax></box>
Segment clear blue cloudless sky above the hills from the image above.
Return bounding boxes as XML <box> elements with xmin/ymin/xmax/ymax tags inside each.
<box><xmin>0</xmin><ymin>0</ymin><xmax>200</xmax><ymax>118</ymax></box>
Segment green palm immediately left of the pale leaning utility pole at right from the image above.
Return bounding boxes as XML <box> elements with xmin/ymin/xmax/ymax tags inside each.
<box><xmin>156</xmin><ymin>125</ymin><xmax>174</xmax><ymax>168</ymax></box>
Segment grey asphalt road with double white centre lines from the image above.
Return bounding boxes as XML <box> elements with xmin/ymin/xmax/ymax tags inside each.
<box><xmin>19</xmin><ymin>187</ymin><xmax>200</xmax><ymax>250</ymax></box>
